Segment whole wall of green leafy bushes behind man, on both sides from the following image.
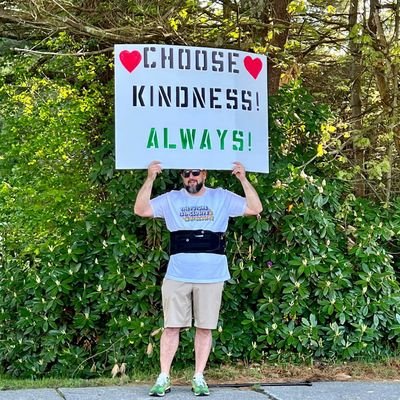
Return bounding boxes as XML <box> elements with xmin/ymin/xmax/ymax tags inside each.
<box><xmin>0</xmin><ymin>42</ymin><xmax>400</xmax><ymax>377</ymax></box>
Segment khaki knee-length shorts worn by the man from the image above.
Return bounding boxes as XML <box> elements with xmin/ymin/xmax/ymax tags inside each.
<box><xmin>161</xmin><ymin>279</ymin><xmax>224</xmax><ymax>329</ymax></box>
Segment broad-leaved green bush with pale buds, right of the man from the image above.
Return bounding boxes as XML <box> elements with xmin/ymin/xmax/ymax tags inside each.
<box><xmin>217</xmin><ymin>173</ymin><xmax>400</xmax><ymax>361</ymax></box>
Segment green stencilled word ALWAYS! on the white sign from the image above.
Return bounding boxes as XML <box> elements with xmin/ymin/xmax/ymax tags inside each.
<box><xmin>146</xmin><ymin>128</ymin><xmax>251</xmax><ymax>151</ymax></box>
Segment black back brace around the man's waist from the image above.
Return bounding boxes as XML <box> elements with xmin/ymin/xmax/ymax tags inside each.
<box><xmin>169</xmin><ymin>230</ymin><xmax>226</xmax><ymax>255</ymax></box>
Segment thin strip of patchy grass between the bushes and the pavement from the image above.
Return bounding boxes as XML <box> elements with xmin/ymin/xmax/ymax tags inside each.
<box><xmin>0</xmin><ymin>358</ymin><xmax>400</xmax><ymax>390</ymax></box>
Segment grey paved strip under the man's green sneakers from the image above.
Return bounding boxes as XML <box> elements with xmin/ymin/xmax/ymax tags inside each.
<box><xmin>0</xmin><ymin>381</ymin><xmax>400</xmax><ymax>400</ymax></box>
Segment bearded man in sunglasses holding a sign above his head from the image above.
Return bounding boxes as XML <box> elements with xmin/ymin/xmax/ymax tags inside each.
<box><xmin>134</xmin><ymin>161</ymin><xmax>262</xmax><ymax>397</ymax></box>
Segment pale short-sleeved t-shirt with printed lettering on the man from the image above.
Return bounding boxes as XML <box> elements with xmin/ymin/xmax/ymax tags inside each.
<box><xmin>150</xmin><ymin>187</ymin><xmax>246</xmax><ymax>283</ymax></box>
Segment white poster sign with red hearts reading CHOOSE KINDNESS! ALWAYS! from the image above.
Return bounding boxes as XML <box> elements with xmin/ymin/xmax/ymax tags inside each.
<box><xmin>115</xmin><ymin>44</ymin><xmax>268</xmax><ymax>172</ymax></box>
